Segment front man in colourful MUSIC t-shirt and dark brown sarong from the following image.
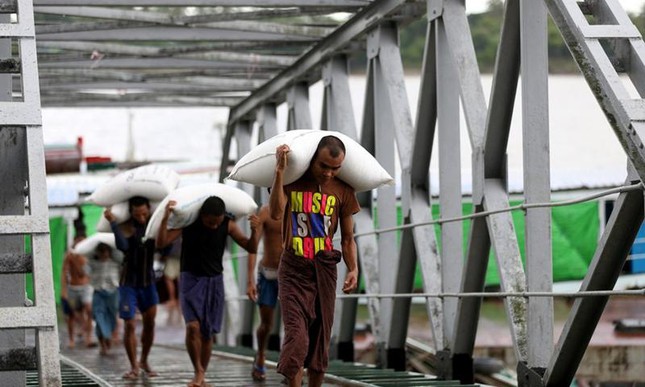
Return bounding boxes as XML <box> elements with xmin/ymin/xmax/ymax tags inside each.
<box><xmin>269</xmin><ymin>136</ymin><xmax>360</xmax><ymax>386</ymax></box>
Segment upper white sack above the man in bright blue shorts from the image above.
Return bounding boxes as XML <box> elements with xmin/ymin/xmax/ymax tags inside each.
<box><xmin>87</xmin><ymin>164</ymin><xmax>179</xmax><ymax>207</ymax></box>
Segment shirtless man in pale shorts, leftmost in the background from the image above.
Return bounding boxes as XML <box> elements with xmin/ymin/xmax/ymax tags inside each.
<box><xmin>60</xmin><ymin>235</ymin><xmax>96</xmax><ymax>348</ymax></box>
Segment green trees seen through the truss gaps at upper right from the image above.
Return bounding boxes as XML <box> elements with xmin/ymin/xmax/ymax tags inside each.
<box><xmin>400</xmin><ymin>0</ymin><xmax>645</xmax><ymax>73</ymax></box>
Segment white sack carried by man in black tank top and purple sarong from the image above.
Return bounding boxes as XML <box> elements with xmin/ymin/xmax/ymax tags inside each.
<box><xmin>146</xmin><ymin>183</ymin><xmax>258</xmax><ymax>239</ymax></box>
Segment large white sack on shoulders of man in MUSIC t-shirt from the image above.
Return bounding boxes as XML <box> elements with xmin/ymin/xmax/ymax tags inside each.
<box><xmin>227</xmin><ymin>129</ymin><xmax>394</xmax><ymax>192</ymax></box>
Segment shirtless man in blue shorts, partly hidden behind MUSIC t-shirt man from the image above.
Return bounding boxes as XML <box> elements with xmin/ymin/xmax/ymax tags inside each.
<box><xmin>246</xmin><ymin>205</ymin><xmax>282</xmax><ymax>381</ymax></box>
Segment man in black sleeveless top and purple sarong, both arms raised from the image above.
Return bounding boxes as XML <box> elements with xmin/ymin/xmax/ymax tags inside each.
<box><xmin>156</xmin><ymin>196</ymin><xmax>257</xmax><ymax>387</ymax></box>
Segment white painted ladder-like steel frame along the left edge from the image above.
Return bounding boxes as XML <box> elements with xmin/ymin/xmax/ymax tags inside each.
<box><xmin>0</xmin><ymin>0</ymin><xmax>62</xmax><ymax>386</ymax></box>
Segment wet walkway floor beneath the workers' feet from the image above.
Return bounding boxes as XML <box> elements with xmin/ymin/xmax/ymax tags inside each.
<box><xmin>49</xmin><ymin>307</ymin><xmax>468</xmax><ymax>387</ymax></box>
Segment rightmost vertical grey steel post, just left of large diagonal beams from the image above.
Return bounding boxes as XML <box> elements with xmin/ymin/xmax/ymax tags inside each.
<box><xmin>520</xmin><ymin>0</ymin><xmax>554</xmax><ymax>372</ymax></box>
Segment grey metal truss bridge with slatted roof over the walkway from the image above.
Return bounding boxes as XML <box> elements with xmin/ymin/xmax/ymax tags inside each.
<box><xmin>0</xmin><ymin>0</ymin><xmax>645</xmax><ymax>386</ymax></box>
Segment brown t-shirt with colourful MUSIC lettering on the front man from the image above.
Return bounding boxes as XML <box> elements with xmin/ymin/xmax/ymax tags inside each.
<box><xmin>282</xmin><ymin>179</ymin><xmax>361</xmax><ymax>259</ymax></box>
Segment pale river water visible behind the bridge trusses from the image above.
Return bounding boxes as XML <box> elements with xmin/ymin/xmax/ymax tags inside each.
<box><xmin>42</xmin><ymin>75</ymin><xmax>626</xmax><ymax>190</ymax></box>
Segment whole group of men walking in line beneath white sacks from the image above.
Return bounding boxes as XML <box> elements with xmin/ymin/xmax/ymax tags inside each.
<box><xmin>63</xmin><ymin>135</ymin><xmax>360</xmax><ymax>387</ymax></box>
